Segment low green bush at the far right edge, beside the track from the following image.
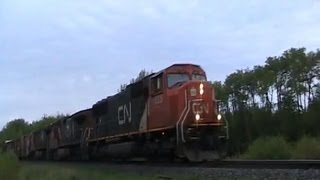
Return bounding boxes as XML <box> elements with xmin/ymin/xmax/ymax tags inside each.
<box><xmin>292</xmin><ymin>136</ymin><xmax>320</xmax><ymax>159</ymax></box>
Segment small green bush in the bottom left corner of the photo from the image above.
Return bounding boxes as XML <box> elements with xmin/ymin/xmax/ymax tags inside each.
<box><xmin>0</xmin><ymin>152</ymin><xmax>20</xmax><ymax>179</ymax></box>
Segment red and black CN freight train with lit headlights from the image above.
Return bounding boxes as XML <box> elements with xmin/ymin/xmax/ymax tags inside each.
<box><xmin>1</xmin><ymin>64</ymin><xmax>228</xmax><ymax>162</ymax></box>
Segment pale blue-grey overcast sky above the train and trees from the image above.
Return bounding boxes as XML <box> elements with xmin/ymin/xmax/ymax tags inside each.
<box><xmin>0</xmin><ymin>0</ymin><xmax>320</xmax><ymax>127</ymax></box>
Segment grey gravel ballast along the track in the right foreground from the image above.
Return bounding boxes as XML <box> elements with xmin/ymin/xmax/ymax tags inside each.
<box><xmin>101</xmin><ymin>165</ymin><xmax>320</xmax><ymax>180</ymax></box>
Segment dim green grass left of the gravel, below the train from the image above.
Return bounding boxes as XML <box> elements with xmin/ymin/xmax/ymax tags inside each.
<box><xmin>0</xmin><ymin>149</ymin><xmax>200</xmax><ymax>180</ymax></box>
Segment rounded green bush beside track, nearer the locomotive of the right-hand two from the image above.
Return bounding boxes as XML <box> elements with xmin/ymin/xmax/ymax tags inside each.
<box><xmin>243</xmin><ymin>136</ymin><xmax>291</xmax><ymax>159</ymax></box>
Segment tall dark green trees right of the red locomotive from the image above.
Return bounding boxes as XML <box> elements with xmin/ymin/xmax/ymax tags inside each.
<box><xmin>212</xmin><ymin>48</ymin><xmax>320</xmax><ymax>153</ymax></box>
